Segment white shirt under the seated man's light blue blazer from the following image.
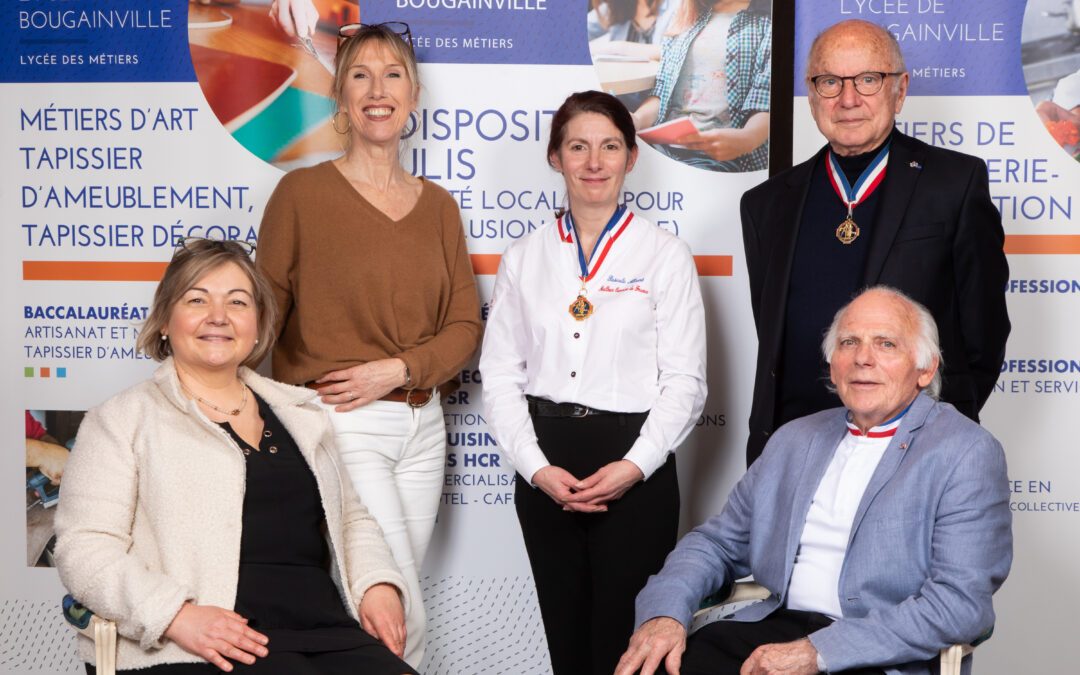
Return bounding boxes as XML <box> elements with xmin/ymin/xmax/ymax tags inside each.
<box><xmin>787</xmin><ymin>417</ymin><xmax>903</xmax><ymax>619</ymax></box>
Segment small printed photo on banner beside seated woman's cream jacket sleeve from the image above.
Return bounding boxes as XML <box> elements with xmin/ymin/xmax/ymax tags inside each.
<box><xmin>25</xmin><ymin>410</ymin><xmax>85</xmax><ymax>567</ymax></box>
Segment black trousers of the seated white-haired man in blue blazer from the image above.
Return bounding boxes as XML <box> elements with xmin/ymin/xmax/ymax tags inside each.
<box><xmin>679</xmin><ymin>609</ymin><xmax>882</xmax><ymax>675</ymax></box>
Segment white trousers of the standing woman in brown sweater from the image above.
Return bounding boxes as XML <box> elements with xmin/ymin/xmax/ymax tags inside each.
<box><xmin>323</xmin><ymin>396</ymin><xmax>446</xmax><ymax>669</ymax></box>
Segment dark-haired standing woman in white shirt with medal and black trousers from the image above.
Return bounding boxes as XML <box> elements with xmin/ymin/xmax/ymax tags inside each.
<box><xmin>480</xmin><ymin>92</ymin><xmax>705</xmax><ymax>675</ymax></box>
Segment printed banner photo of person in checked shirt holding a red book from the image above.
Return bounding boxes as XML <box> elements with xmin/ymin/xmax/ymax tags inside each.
<box><xmin>585</xmin><ymin>0</ymin><xmax>772</xmax><ymax>173</ymax></box>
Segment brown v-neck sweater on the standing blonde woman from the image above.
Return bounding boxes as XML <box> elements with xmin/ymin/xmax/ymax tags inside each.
<box><xmin>256</xmin><ymin>162</ymin><xmax>483</xmax><ymax>387</ymax></box>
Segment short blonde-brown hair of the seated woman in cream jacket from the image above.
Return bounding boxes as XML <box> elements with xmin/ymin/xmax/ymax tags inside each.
<box><xmin>135</xmin><ymin>239</ymin><xmax>278</xmax><ymax>367</ymax></box>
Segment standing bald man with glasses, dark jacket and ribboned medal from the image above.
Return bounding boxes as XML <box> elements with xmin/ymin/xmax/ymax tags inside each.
<box><xmin>742</xmin><ymin>21</ymin><xmax>1010</xmax><ymax>463</ymax></box>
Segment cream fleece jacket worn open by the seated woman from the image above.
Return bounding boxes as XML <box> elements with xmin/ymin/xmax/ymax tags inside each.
<box><xmin>56</xmin><ymin>359</ymin><xmax>409</xmax><ymax>669</ymax></box>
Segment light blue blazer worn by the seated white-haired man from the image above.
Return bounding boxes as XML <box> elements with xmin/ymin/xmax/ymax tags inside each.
<box><xmin>637</xmin><ymin>394</ymin><xmax>1012</xmax><ymax>675</ymax></box>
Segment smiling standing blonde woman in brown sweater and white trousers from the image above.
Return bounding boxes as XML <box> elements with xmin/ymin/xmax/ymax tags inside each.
<box><xmin>257</xmin><ymin>23</ymin><xmax>481</xmax><ymax>665</ymax></box>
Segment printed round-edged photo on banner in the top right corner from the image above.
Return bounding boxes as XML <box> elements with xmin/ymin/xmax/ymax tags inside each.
<box><xmin>1021</xmin><ymin>0</ymin><xmax>1080</xmax><ymax>161</ymax></box>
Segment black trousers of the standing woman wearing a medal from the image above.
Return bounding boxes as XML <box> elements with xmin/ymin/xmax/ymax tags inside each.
<box><xmin>514</xmin><ymin>413</ymin><xmax>679</xmax><ymax>675</ymax></box>
